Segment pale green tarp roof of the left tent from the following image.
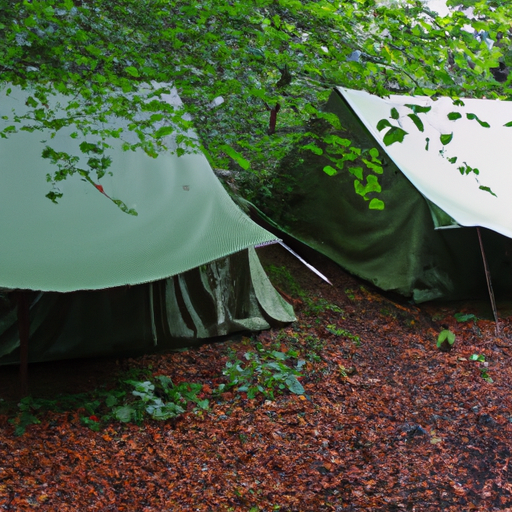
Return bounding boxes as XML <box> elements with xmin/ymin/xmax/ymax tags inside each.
<box><xmin>0</xmin><ymin>89</ymin><xmax>275</xmax><ymax>292</ymax></box>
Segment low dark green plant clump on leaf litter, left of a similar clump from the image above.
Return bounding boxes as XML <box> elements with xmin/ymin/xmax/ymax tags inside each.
<box><xmin>106</xmin><ymin>375</ymin><xmax>209</xmax><ymax>423</ymax></box>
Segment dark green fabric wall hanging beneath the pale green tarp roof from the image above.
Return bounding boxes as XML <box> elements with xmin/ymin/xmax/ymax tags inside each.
<box><xmin>0</xmin><ymin>249</ymin><xmax>295</xmax><ymax>364</ymax></box>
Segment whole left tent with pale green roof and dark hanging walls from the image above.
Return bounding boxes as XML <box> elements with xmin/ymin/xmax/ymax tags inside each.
<box><xmin>0</xmin><ymin>87</ymin><xmax>294</xmax><ymax>364</ymax></box>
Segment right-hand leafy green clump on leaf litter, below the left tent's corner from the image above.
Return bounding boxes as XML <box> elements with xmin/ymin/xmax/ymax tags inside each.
<box><xmin>218</xmin><ymin>343</ymin><xmax>306</xmax><ymax>400</ymax></box>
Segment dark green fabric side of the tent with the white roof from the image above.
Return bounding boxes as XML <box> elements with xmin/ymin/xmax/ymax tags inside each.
<box><xmin>258</xmin><ymin>92</ymin><xmax>512</xmax><ymax>302</ymax></box>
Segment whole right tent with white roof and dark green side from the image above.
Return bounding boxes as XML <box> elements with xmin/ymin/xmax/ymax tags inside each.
<box><xmin>259</xmin><ymin>88</ymin><xmax>512</xmax><ymax>302</ymax></box>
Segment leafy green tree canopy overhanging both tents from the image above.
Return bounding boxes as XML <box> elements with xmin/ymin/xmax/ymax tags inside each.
<box><xmin>0</xmin><ymin>0</ymin><xmax>512</xmax><ymax>208</ymax></box>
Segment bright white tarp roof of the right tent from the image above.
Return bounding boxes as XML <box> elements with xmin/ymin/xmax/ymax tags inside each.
<box><xmin>338</xmin><ymin>87</ymin><xmax>512</xmax><ymax>238</ymax></box>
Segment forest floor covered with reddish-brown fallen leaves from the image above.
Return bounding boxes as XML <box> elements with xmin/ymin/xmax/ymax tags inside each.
<box><xmin>0</xmin><ymin>243</ymin><xmax>512</xmax><ymax>512</ymax></box>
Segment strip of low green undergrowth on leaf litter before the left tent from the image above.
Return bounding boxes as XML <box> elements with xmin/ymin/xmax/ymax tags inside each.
<box><xmin>9</xmin><ymin>343</ymin><xmax>305</xmax><ymax>435</ymax></box>
